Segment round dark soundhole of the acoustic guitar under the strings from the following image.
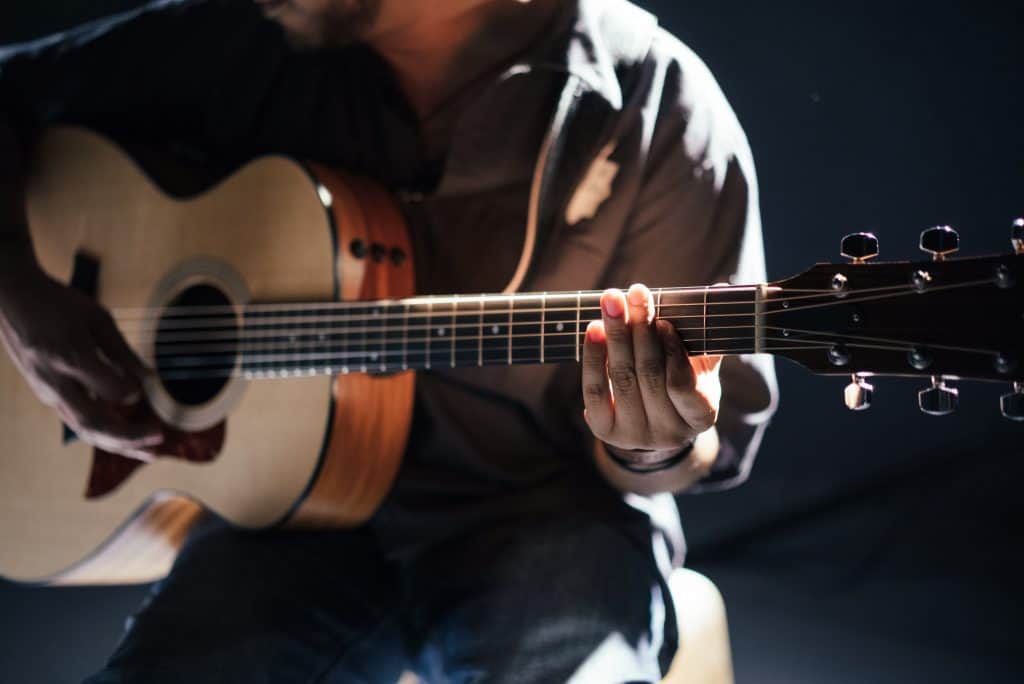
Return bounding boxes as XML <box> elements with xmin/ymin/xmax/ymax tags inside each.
<box><xmin>156</xmin><ymin>284</ymin><xmax>239</xmax><ymax>407</ymax></box>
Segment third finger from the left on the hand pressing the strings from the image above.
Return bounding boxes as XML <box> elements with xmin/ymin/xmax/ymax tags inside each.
<box><xmin>626</xmin><ymin>285</ymin><xmax>687</xmax><ymax>440</ymax></box>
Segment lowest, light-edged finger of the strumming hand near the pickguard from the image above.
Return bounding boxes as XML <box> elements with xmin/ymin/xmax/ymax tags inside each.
<box><xmin>52</xmin><ymin>378</ymin><xmax>163</xmax><ymax>454</ymax></box>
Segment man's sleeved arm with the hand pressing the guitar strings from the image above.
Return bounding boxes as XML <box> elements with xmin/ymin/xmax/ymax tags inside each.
<box><xmin>584</xmin><ymin>46</ymin><xmax>776</xmax><ymax>494</ymax></box>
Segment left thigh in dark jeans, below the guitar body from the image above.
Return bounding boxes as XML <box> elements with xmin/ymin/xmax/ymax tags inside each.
<box><xmin>87</xmin><ymin>520</ymin><xmax>400</xmax><ymax>684</ymax></box>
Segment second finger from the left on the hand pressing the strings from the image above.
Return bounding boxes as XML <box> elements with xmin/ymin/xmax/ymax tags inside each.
<box><xmin>601</xmin><ymin>290</ymin><xmax>647</xmax><ymax>432</ymax></box>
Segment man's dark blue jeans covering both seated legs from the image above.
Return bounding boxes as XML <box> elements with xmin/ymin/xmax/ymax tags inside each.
<box><xmin>86</xmin><ymin>511</ymin><xmax>676</xmax><ymax>684</ymax></box>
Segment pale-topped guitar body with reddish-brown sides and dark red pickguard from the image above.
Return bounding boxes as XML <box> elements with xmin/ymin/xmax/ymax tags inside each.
<box><xmin>0</xmin><ymin>128</ymin><xmax>414</xmax><ymax>584</ymax></box>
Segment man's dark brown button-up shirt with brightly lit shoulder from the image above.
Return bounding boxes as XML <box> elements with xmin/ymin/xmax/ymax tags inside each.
<box><xmin>0</xmin><ymin>0</ymin><xmax>776</xmax><ymax>558</ymax></box>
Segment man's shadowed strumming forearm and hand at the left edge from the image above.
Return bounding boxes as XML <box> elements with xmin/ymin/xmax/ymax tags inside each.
<box><xmin>0</xmin><ymin>112</ymin><xmax>163</xmax><ymax>459</ymax></box>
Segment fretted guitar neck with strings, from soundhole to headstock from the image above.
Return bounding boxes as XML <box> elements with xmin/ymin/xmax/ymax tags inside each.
<box><xmin>226</xmin><ymin>286</ymin><xmax>764</xmax><ymax>378</ymax></box>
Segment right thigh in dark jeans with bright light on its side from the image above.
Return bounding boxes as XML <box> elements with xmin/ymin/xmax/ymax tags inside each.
<box><xmin>403</xmin><ymin>514</ymin><xmax>677</xmax><ymax>682</ymax></box>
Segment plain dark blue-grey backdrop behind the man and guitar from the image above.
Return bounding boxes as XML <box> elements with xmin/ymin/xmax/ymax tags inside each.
<box><xmin>0</xmin><ymin>0</ymin><xmax>1024</xmax><ymax>684</ymax></box>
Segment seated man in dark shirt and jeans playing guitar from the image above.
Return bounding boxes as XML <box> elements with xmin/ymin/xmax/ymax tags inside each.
<box><xmin>0</xmin><ymin>0</ymin><xmax>774</xmax><ymax>683</ymax></box>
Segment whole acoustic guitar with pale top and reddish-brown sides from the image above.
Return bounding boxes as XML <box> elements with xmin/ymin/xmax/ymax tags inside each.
<box><xmin>0</xmin><ymin>128</ymin><xmax>1024</xmax><ymax>584</ymax></box>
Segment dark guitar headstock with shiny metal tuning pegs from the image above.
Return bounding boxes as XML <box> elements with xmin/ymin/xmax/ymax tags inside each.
<box><xmin>761</xmin><ymin>219</ymin><xmax>1024</xmax><ymax>421</ymax></box>
